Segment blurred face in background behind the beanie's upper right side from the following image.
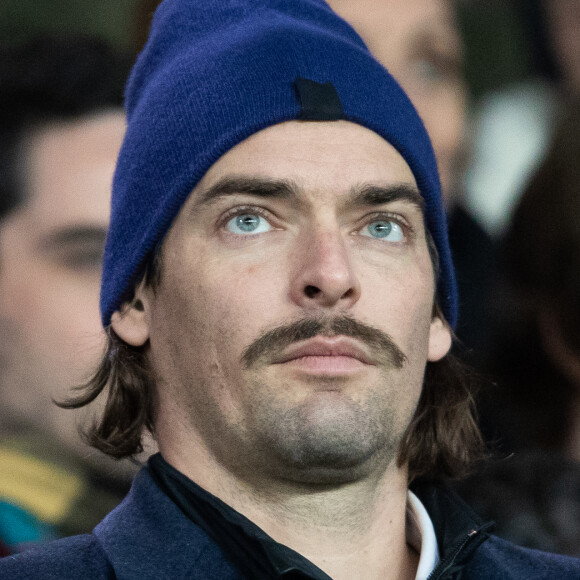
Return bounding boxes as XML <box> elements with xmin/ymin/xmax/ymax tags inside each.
<box><xmin>328</xmin><ymin>0</ymin><xmax>467</xmax><ymax>206</ymax></box>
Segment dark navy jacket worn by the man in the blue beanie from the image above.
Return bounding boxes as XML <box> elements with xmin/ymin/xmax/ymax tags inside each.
<box><xmin>0</xmin><ymin>468</ymin><xmax>580</xmax><ymax>580</ymax></box>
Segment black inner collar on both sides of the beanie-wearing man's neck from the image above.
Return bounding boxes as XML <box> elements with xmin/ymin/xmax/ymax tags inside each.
<box><xmin>149</xmin><ymin>454</ymin><xmax>490</xmax><ymax>580</ymax></box>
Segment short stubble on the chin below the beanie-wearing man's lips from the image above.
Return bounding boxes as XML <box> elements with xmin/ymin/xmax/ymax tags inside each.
<box><xmin>242</xmin><ymin>373</ymin><xmax>413</xmax><ymax>484</ymax></box>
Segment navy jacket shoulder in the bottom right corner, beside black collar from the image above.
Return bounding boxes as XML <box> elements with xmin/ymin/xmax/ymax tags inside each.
<box><xmin>466</xmin><ymin>535</ymin><xmax>580</xmax><ymax>580</ymax></box>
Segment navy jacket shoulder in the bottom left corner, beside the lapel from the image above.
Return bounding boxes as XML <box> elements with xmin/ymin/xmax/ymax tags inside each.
<box><xmin>0</xmin><ymin>534</ymin><xmax>115</xmax><ymax>580</ymax></box>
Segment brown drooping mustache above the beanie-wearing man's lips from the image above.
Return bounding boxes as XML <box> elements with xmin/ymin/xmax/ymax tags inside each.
<box><xmin>242</xmin><ymin>316</ymin><xmax>407</xmax><ymax>369</ymax></box>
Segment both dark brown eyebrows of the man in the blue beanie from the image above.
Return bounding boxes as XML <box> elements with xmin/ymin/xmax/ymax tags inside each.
<box><xmin>192</xmin><ymin>176</ymin><xmax>425</xmax><ymax>212</ymax></box>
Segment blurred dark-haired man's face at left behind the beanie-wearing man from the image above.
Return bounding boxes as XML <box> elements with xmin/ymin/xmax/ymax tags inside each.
<box><xmin>0</xmin><ymin>112</ymin><xmax>125</xmax><ymax>444</ymax></box>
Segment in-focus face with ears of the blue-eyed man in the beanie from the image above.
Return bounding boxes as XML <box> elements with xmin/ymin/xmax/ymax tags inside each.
<box><xmin>121</xmin><ymin>121</ymin><xmax>450</xmax><ymax>482</ymax></box>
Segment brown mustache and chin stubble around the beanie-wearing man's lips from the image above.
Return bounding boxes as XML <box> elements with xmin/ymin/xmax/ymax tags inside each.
<box><xmin>231</xmin><ymin>315</ymin><xmax>412</xmax><ymax>483</ymax></box>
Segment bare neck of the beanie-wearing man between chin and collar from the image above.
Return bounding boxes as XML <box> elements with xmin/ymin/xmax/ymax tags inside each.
<box><xmin>161</xmin><ymin>440</ymin><xmax>419</xmax><ymax>580</ymax></box>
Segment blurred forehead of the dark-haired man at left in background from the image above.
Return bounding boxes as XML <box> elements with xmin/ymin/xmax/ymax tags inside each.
<box><xmin>22</xmin><ymin>112</ymin><xmax>125</xmax><ymax>229</ymax></box>
